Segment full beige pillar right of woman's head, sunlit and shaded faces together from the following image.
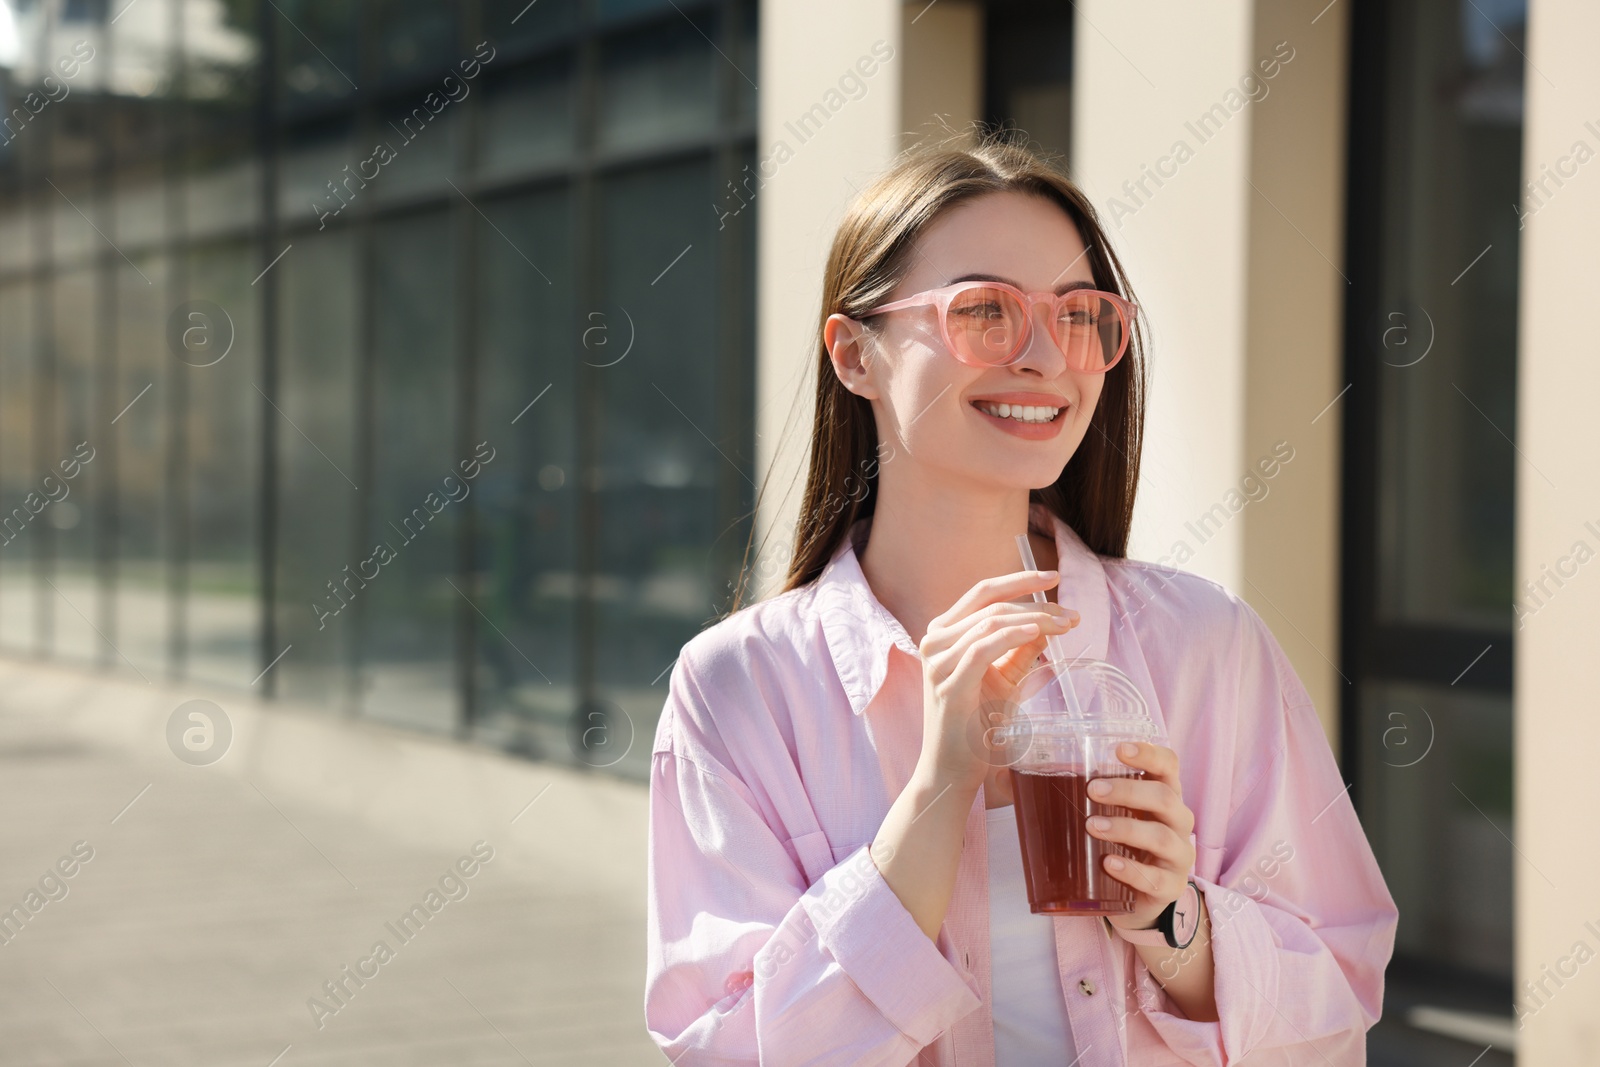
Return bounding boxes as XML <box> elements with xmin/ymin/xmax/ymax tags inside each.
<box><xmin>1072</xmin><ymin>0</ymin><xmax>1347</xmax><ymax>744</ymax></box>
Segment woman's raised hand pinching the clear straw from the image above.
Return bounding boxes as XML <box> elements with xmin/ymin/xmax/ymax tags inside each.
<box><xmin>917</xmin><ymin>571</ymin><xmax>1078</xmax><ymax>793</ymax></box>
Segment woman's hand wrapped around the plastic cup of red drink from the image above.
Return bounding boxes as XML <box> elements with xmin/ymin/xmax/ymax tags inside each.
<box><xmin>1088</xmin><ymin>741</ymin><xmax>1195</xmax><ymax>929</ymax></box>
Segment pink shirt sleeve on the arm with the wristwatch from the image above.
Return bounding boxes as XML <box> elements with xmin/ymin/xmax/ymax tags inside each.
<box><xmin>1131</xmin><ymin>608</ymin><xmax>1398</xmax><ymax>1067</ymax></box>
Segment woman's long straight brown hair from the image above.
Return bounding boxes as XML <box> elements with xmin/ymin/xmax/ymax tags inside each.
<box><xmin>728</xmin><ymin>130</ymin><xmax>1146</xmax><ymax>613</ymax></box>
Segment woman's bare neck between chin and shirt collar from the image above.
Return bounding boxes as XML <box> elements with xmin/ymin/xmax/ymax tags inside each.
<box><xmin>861</xmin><ymin>467</ymin><xmax>1056</xmax><ymax>641</ymax></box>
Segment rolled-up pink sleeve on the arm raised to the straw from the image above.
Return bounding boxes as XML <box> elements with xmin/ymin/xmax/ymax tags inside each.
<box><xmin>645</xmin><ymin>659</ymin><xmax>979</xmax><ymax>1065</ymax></box>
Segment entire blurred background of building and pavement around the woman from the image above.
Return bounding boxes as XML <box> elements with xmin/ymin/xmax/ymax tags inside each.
<box><xmin>0</xmin><ymin>0</ymin><xmax>1600</xmax><ymax>1065</ymax></box>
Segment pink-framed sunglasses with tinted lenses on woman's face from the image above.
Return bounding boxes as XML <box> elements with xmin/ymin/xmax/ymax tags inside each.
<box><xmin>861</xmin><ymin>282</ymin><xmax>1136</xmax><ymax>373</ymax></box>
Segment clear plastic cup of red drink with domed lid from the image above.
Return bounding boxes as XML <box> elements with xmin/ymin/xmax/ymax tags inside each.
<box><xmin>992</xmin><ymin>659</ymin><xmax>1166</xmax><ymax>915</ymax></box>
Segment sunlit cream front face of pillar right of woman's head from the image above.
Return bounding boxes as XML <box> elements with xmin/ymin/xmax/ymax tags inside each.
<box><xmin>1072</xmin><ymin>0</ymin><xmax>1253</xmax><ymax>601</ymax></box>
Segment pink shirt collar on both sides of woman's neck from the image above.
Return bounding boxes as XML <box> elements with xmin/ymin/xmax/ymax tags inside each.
<box><xmin>814</xmin><ymin>502</ymin><xmax>1110</xmax><ymax>715</ymax></box>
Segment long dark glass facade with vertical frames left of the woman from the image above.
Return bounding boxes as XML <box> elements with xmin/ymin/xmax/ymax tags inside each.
<box><xmin>0</xmin><ymin>0</ymin><xmax>757</xmax><ymax>774</ymax></box>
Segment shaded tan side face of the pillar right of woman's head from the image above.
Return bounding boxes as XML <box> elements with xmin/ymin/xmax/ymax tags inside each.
<box><xmin>1237</xmin><ymin>0</ymin><xmax>1350</xmax><ymax>753</ymax></box>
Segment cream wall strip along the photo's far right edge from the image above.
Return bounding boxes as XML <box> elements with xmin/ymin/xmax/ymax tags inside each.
<box><xmin>1512</xmin><ymin>0</ymin><xmax>1600</xmax><ymax>1067</ymax></box>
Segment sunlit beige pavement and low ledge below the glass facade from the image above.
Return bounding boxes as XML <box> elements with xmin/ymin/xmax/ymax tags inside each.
<box><xmin>0</xmin><ymin>661</ymin><xmax>666</xmax><ymax>1067</ymax></box>
